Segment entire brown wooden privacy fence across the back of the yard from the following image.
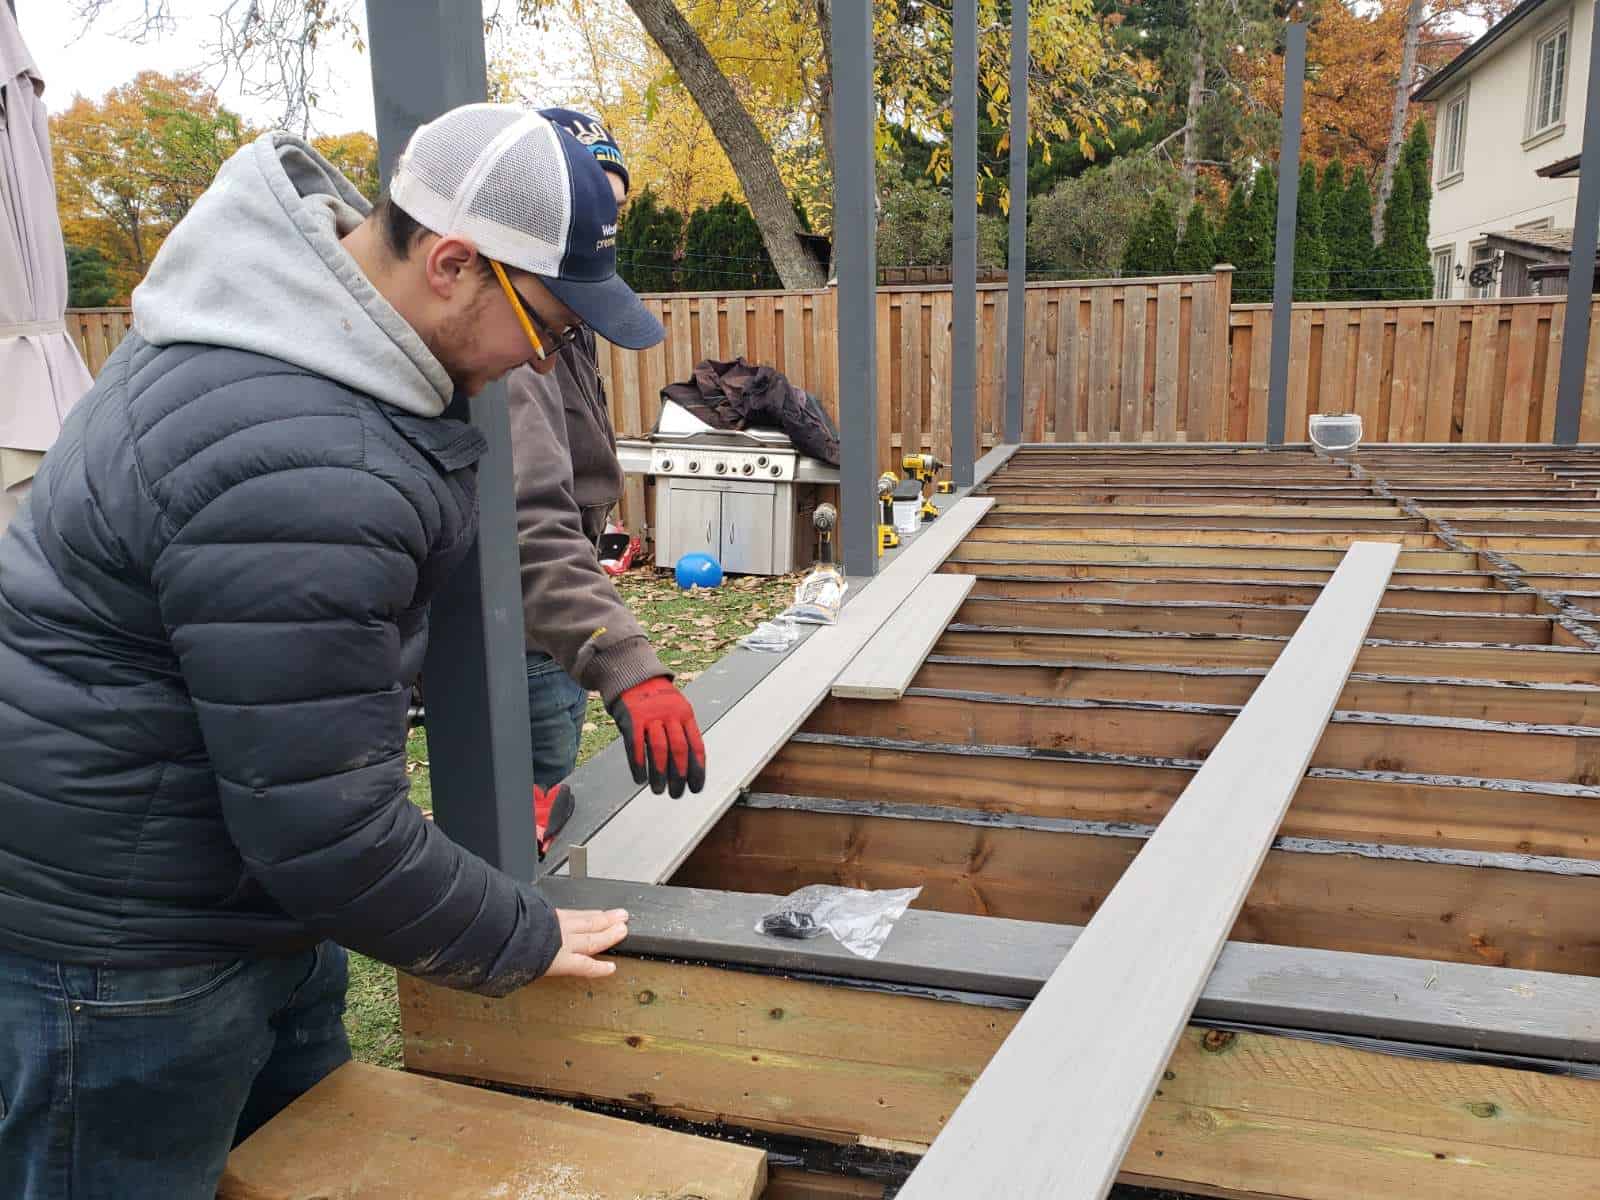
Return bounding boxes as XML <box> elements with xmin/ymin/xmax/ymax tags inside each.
<box><xmin>67</xmin><ymin>280</ymin><xmax>1600</xmax><ymax>467</ymax></box>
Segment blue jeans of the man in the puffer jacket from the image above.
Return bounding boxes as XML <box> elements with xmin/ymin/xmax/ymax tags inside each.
<box><xmin>0</xmin><ymin>942</ymin><xmax>350</xmax><ymax>1200</ymax></box>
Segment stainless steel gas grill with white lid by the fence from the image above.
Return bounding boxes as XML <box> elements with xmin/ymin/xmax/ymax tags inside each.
<box><xmin>618</xmin><ymin>400</ymin><xmax>838</xmax><ymax>574</ymax></box>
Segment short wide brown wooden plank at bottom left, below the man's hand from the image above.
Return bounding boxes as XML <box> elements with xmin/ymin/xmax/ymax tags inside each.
<box><xmin>218</xmin><ymin>1062</ymin><xmax>766</xmax><ymax>1200</ymax></box>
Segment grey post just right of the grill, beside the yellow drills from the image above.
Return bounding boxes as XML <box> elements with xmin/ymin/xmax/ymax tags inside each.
<box><xmin>834</xmin><ymin>3</ymin><xmax>883</xmax><ymax>576</ymax></box>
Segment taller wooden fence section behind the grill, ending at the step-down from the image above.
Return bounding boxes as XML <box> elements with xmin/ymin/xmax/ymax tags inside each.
<box><xmin>600</xmin><ymin>269</ymin><xmax>1232</xmax><ymax>466</ymax></box>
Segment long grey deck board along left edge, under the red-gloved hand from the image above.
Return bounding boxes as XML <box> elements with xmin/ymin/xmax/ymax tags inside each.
<box><xmin>587</xmin><ymin>498</ymin><xmax>994</xmax><ymax>883</ymax></box>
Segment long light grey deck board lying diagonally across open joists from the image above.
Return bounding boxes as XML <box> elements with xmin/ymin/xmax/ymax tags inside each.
<box><xmin>901</xmin><ymin>542</ymin><xmax>1398</xmax><ymax>1200</ymax></box>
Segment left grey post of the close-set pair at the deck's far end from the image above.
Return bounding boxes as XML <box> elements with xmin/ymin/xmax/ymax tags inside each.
<box><xmin>950</xmin><ymin>0</ymin><xmax>978</xmax><ymax>488</ymax></box>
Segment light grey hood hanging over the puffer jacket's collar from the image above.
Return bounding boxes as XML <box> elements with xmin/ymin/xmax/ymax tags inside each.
<box><xmin>133</xmin><ymin>133</ymin><xmax>453</xmax><ymax>416</ymax></box>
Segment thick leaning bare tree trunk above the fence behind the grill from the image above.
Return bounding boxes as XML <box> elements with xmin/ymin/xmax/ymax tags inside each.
<box><xmin>627</xmin><ymin>0</ymin><xmax>827</xmax><ymax>288</ymax></box>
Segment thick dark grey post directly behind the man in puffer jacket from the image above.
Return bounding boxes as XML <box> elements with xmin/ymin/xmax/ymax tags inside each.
<box><xmin>366</xmin><ymin>0</ymin><xmax>536</xmax><ymax>880</ymax></box>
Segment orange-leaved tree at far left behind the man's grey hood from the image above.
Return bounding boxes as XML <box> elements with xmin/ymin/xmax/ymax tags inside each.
<box><xmin>50</xmin><ymin>70</ymin><xmax>253</xmax><ymax>301</ymax></box>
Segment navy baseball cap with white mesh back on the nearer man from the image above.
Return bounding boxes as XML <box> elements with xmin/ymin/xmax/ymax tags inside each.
<box><xmin>389</xmin><ymin>104</ymin><xmax>666</xmax><ymax>350</ymax></box>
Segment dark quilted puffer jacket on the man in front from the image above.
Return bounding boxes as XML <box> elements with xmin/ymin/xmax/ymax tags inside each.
<box><xmin>0</xmin><ymin>336</ymin><xmax>558</xmax><ymax>995</ymax></box>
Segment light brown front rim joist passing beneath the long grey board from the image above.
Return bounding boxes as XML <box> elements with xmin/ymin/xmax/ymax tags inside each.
<box><xmin>400</xmin><ymin>953</ymin><xmax>1600</xmax><ymax>1200</ymax></box>
